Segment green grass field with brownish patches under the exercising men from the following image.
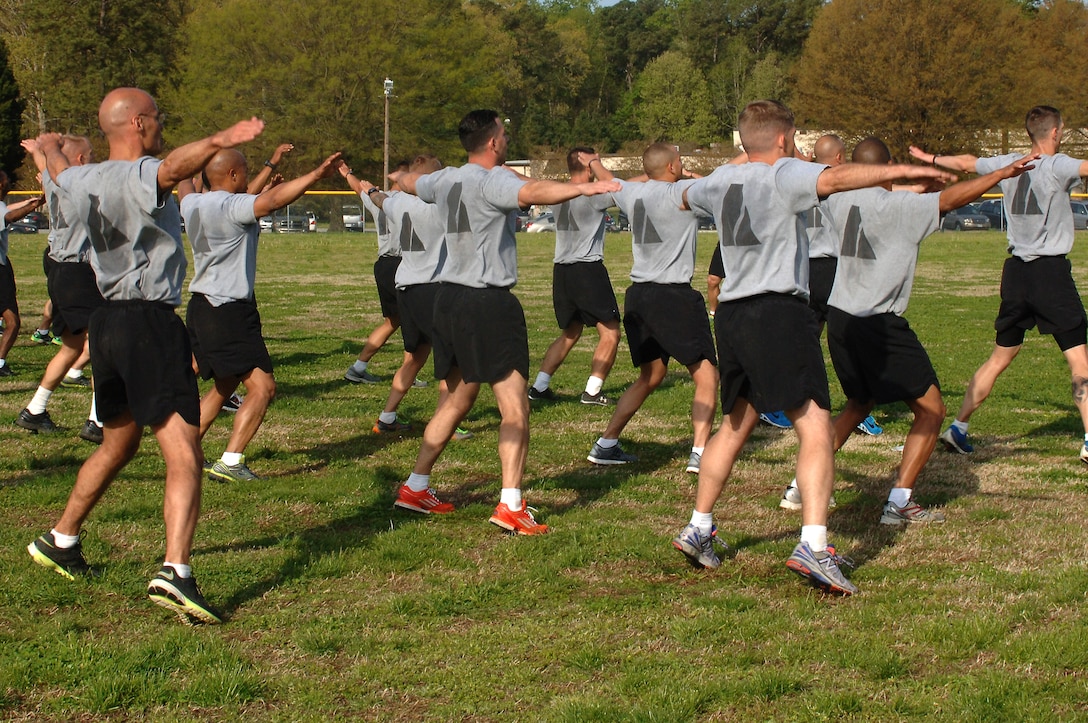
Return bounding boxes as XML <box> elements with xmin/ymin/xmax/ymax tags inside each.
<box><xmin>0</xmin><ymin>232</ymin><xmax>1088</xmax><ymax>722</ymax></box>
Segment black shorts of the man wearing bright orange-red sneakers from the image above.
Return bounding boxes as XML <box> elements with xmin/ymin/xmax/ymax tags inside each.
<box><xmin>434</xmin><ymin>284</ymin><xmax>529</xmax><ymax>384</ymax></box>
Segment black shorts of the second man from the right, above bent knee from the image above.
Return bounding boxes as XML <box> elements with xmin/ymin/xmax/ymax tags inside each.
<box><xmin>827</xmin><ymin>307</ymin><xmax>940</xmax><ymax>404</ymax></box>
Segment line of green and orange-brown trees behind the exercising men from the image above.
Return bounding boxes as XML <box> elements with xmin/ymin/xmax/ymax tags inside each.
<box><xmin>0</xmin><ymin>0</ymin><xmax>1088</xmax><ymax>185</ymax></box>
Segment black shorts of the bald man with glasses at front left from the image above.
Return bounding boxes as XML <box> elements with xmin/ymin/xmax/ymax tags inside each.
<box><xmin>87</xmin><ymin>301</ymin><xmax>200</xmax><ymax>426</ymax></box>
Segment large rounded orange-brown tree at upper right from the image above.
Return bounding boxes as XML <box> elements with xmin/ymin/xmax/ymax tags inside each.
<box><xmin>794</xmin><ymin>0</ymin><xmax>1033</xmax><ymax>157</ymax></box>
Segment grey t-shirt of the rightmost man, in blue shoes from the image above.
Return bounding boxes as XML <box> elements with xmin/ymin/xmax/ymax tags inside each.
<box><xmin>975</xmin><ymin>153</ymin><xmax>1080</xmax><ymax>261</ymax></box>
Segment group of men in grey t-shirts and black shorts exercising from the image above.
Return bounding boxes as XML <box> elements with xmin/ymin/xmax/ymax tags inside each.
<box><xmin>14</xmin><ymin>88</ymin><xmax>1088</xmax><ymax>623</ymax></box>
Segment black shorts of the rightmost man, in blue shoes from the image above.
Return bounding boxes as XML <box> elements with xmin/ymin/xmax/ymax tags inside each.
<box><xmin>993</xmin><ymin>255</ymin><xmax>1088</xmax><ymax>351</ymax></box>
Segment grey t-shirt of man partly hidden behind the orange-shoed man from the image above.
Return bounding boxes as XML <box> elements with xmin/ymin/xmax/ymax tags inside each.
<box><xmin>382</xmin><ymin>194</ymin><xmax>445</xmax><ymax>289</ymax></box>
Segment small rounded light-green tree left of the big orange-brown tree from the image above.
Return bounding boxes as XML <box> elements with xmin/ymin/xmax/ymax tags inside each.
<box><xmin>635</xmin><ymin>50</ymin><xmax>715</xmax><ymax>144</ymax></box>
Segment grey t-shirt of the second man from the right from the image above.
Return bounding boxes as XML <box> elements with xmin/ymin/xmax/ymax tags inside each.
<box><xmin>824</xmin><ymin>188</ymin><xmax>941</xmax><ymax>316</ymax></box>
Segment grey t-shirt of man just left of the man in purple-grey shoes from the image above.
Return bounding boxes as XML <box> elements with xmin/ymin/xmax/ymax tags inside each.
<box><xmin>613</xmin><ymin>180</ymin><xmax>698</xmax><ymax>284</ymax></box>
